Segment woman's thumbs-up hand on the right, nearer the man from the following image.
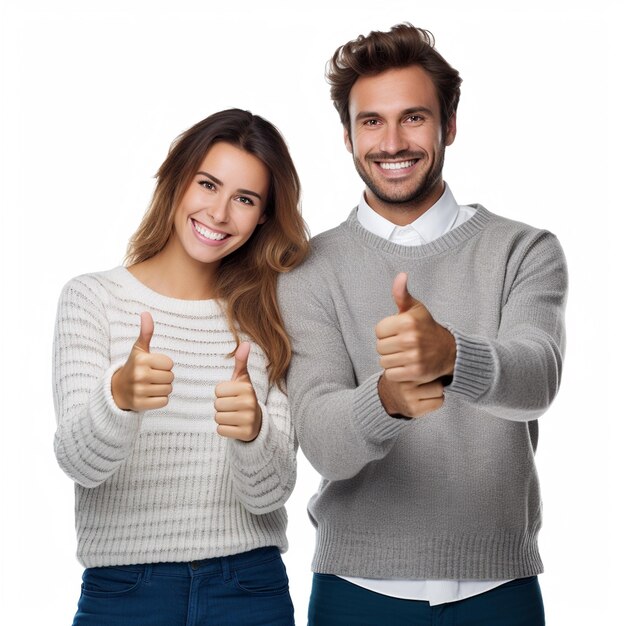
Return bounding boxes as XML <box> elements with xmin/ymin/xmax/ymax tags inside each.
<box><xmin>215</xmin><ymin>342</ymin><xmax>262</xmax><ymax>441</ymax></box>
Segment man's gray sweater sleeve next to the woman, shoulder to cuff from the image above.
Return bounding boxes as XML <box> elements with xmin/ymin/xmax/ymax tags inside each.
<box><xmin>278</xmin><ymin>270</ymin><xmax>411</xmax><ymax>480</ymax></box>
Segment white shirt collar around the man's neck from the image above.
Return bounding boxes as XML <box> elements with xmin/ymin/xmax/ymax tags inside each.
<box><xmin>357</xmin><ymin>184</ymin><xmax>459</xmax><ymax>243</ymax></box>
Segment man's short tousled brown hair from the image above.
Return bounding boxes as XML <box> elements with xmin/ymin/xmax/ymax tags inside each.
<box><xmin>326</xmin><ymin>23</ymin><xmax>462</xmax><ymax>134</ymax></box>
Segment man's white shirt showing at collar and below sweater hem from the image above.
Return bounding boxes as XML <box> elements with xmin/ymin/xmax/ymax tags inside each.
<box><xmin>341</xmin><ymin>184</ymin><xmax>508</xmax><ymax>605</ymax></box>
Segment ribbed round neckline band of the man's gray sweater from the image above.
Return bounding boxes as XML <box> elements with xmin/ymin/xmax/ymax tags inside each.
<box><xmin>344</xmin><ymin>204</ymin><xmax>492</xmax><ymax>259</ymax></box>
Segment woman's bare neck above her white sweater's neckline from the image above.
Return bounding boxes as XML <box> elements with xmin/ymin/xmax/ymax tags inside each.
<box><xmin>128</xmin><ymin>240</ymin><xmax>217</xmax><ymax>300</ymax></box>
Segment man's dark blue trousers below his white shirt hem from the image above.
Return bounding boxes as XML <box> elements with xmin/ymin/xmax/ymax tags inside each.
<box><xmin>309</xmin><ymin>574</ymin><xmax>545</xmax><ymax>626</ymax></box>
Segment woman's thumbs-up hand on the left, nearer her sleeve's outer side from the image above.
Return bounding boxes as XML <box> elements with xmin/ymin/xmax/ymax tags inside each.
<box><xmin>111</xmin><ymin>312</ymin><xmax>174</xmax><ymax>411</ymax></box>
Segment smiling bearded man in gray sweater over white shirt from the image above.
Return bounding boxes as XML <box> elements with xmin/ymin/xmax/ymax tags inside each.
<box><xmin>279</xmin><ymin>24</ymin><xmax>567</xmax><ymax>626</ymax></box>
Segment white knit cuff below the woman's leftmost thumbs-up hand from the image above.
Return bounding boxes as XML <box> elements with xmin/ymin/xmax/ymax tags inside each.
<box><xmin>89</xmin><ymin>365</ymin><xmax>141</xmax><ymax>445</ymax></box>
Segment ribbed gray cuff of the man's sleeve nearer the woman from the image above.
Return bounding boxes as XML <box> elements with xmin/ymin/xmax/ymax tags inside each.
<box><xmin>353</xmin><ymin>372</ymin><xmax>411</xmax><ymax>443</ymax></box>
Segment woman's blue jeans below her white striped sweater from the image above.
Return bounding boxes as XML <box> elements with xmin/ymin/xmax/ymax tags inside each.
<box><xmin>73</xmin><ymin>547</ymin><xmax>294</xmax><ymax>626</ymax></box>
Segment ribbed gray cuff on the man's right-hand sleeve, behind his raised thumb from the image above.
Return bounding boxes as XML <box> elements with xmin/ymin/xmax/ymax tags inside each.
<box><xmin>446</xmin><ymin>326</ymin><xmax>496</xmax><ymax>400</ymax></box>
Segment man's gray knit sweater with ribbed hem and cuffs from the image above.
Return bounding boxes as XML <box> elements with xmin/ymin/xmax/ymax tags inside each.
<box><xmin>279</xmin><ymin>206</ymin><xmax>567</xmax><ymax>580</ymax></box>
